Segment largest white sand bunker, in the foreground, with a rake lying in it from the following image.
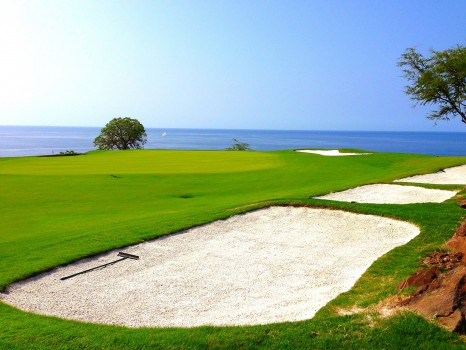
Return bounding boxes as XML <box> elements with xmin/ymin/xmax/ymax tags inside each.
<box><xmin>0</xmin><ymin>207</ymin><xmax>419</xmax><ymax>327</ymax></box>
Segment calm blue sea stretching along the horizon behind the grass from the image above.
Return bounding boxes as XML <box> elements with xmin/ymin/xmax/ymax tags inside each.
<box><xmin>0</xmin><ymin>126</ymin><xmax>466</xmax><ymax>157</ymax></box>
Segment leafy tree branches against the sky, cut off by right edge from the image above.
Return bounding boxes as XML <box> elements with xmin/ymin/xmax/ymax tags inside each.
<box><xmin>398</xmin><ymin>45</ymin><xmax>466</xmax><ymax>123</ymax></box>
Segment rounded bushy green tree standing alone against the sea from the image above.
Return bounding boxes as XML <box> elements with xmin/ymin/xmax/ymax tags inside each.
<box><xmin>94</xmin><ymin>118</ymin><xmax>147</xmax><ymax>149</ymax></box>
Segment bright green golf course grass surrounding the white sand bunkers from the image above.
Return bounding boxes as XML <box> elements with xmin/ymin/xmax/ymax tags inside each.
<box><xmin>0</xmin><ymin>151</ymin><xmax>466</xmax><ymax>349</ymax></box>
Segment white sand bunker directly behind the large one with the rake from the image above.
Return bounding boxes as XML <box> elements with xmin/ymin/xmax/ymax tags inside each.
<box><xmin>314</xmin><ymin>184</ymin><xmax>457</xmax><ymax>204</ymax></box>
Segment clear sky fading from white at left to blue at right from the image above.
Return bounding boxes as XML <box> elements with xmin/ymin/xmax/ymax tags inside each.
<box><xmin>0</xmin><ymin>0</ymin><xmax>466</xmax><ymax>131</ymax></box>
